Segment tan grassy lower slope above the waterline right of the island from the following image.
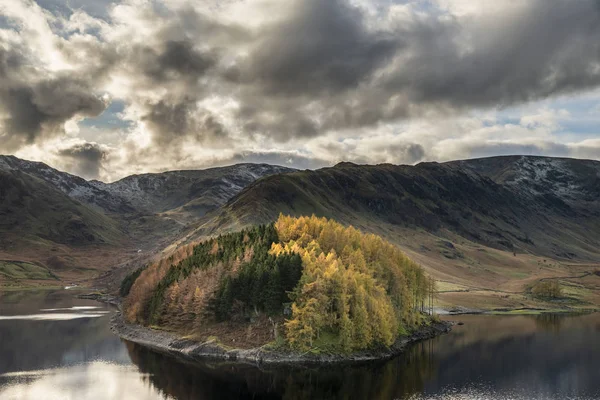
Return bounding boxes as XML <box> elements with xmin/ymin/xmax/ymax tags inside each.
<box><xmin>397</xmin><ymin>233</ymin><xmax>600</xmax><ymax>311</ymax></box>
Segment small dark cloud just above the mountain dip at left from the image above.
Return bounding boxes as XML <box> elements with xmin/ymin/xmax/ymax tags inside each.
<box><xmin>58</xmin><ymin>143</ymin><xmax>107</xmax><ymax>179</ymax></box>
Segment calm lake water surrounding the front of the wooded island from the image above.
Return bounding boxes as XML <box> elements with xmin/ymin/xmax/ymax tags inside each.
<box><xmin>0</xmin><ymin>291</ymin><xmax>600</xmax><ymax>400</ymax></box>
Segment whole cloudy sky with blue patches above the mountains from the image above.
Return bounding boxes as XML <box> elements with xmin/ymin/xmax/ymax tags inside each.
<box><xmin>0</xmin><ymin>0</ymin><xmax>600</xmax><ymax>181</ymax></box>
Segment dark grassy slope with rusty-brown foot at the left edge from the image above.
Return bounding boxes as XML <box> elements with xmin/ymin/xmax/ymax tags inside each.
<box><xmin>0</xmin><ymin>171</ymin><xmax>127</xmax><ymax>286</ymax></box>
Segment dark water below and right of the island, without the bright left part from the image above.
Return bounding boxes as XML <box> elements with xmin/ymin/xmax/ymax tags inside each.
<box><xmin>127</xmin><ymin>314</ymin><xmax>600</xmax><ymax>400</ymax></box>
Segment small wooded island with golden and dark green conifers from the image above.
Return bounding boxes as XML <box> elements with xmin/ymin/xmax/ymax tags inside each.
<box><xmin>112</xmin><ymin>215</ymin><xmax>450</xmax><ymax>363</ymax></box>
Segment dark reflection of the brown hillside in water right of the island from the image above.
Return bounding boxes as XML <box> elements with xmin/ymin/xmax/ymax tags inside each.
<box><xmin>424</xmin><ymin>314</ymin><xmax>600</xmax><ymax>399</ymax></box>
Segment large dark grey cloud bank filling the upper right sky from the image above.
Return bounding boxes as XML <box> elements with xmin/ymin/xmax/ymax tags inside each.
<box><xmin>226</xmin><ymin>0</ymin><xmax>600</xmax><ymax>141</ymax></box>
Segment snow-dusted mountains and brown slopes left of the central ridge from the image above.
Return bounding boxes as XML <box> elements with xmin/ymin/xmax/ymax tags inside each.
<box><xmin>0</xmin><ymin>156</ymin><xmax>292</xmax><ymax>286</ymax></box>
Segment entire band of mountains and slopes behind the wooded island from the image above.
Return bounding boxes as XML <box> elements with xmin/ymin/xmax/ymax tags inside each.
<box><xmin>0</xmin><ymin>156</ymin><xmax>600</xmax><ymax>312</ymax></box>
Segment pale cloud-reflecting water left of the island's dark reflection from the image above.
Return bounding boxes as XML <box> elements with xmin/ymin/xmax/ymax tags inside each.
<box><xmin>0</xmin><ymin>291</ymin><xmax>166</xmax><ymax>400</ymax></box>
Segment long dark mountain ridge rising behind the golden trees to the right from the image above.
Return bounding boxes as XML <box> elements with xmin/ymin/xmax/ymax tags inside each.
<box><xmin>199</xmin><ymin>157</ymin><xmax>600</xmax><ymax>260</ymax></box>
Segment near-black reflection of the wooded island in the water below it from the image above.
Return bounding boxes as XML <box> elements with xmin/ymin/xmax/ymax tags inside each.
<box><xmin>127</xmin><ymin>343</ymin><xmax>436</xmax><ymax>400</ymax></box>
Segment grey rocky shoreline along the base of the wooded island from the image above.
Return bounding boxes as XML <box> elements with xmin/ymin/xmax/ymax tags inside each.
<box><xmin>110</xmin><ymin>312</ymin><xmax>452</xmax><ymax>365</ymax></box>
